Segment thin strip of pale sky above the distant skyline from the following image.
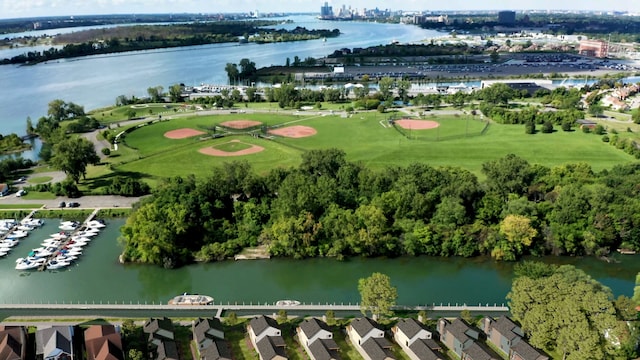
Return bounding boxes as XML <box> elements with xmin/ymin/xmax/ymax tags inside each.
<box><xmin>0</xmin><ymin>0</ymin><xmax>640</xmax><ymax>19</ymax></box>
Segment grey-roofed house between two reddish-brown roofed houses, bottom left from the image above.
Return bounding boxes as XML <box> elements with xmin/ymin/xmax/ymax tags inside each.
<box><xmin>36</xmin><ymin>326</ymin><xmax>74</xmax><ymax>360</ymax></box>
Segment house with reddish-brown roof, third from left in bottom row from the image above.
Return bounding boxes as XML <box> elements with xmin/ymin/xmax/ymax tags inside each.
<box><xmin>84</xmin><ymin>325</ymin><xmax>124</xmax><ymax>360</ymax></box>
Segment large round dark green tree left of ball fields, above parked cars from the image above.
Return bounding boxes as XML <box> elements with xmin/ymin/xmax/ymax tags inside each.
<box><xmin>51</xmin><ymin>138</ymin><xmax>100</xmax><ymax>183</ymax></box>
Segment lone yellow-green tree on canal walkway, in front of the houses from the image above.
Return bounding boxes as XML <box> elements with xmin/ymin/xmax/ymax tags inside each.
<box><xmin>358</xmin><ymin>272</ymin><xmax>398</xmax><ymax>318</ymax></box>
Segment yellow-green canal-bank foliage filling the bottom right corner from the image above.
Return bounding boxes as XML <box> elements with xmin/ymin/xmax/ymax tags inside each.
<box><xmin>507</xmin><ymin>262</ymin><xmax>638</xmax><ymax>360</ymax></box>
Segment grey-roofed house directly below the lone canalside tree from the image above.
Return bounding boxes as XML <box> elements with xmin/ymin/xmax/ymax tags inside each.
<box><xmin>347</xmin><ymin>317</ymin><xmax>395</xmax><ymax>360</ymax></box>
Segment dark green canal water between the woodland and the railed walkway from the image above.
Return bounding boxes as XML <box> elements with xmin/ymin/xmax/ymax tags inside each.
<box><xmin>0</xmin><ymin>219</ymin><xmax>640</xmax><ymax>308</ymax></box>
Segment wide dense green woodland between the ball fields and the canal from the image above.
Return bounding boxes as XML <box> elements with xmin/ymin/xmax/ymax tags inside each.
<box><xmin>122</xmin><ymin>149</ymin><xmax>640</xmax><ymax>267</ymax></box>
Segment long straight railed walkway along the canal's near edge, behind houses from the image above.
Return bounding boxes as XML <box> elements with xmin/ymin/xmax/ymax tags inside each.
<box><xmin>0</xmin><ymin>302</ymin><xmax>509</xmax><ymax>317</ymax></box>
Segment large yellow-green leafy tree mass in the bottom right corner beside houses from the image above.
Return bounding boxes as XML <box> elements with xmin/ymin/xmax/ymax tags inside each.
<box><xmin>507</xmin><ymin>265</ymin><xmax>623</xmax><ymax>360</ymax></box>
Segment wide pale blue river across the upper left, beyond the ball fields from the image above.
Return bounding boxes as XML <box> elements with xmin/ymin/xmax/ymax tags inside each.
<box><xmin>0</xmin><ymin>16</ymin><xmax>439</xmax><ymax>134</ymax></box>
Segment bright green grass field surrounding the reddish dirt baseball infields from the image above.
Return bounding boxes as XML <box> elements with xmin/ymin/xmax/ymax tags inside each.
<box><xmin>94</xmin><ymin>111</ymin><xmax>635</xmax><ymax>184</ymax></box>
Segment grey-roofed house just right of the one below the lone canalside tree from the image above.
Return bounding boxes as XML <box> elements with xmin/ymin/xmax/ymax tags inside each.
<box><xmin>391</xmin><ymin>318</ymin><xmax>442</xmax><ymax>360</ymax></box>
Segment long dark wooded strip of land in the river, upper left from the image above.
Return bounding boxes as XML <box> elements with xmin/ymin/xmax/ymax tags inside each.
<box><xmin>0</xmin><ymin>20</ymin><xmax>340</xmax><ymax>65</ymax></box>
